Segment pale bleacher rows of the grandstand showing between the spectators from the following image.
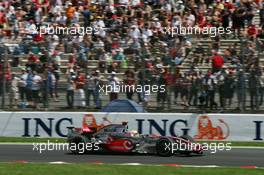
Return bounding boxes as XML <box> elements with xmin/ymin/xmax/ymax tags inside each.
<box><xmin>1</xmin><ymin>1</ymin><xmax>264</xmax><ymax>112</ymax></box>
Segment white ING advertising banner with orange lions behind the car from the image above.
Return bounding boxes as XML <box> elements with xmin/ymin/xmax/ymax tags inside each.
<box><xmin>0</xmin><ymin>112</ymin><xmax>264</xmax><ymax>141</ymax></box>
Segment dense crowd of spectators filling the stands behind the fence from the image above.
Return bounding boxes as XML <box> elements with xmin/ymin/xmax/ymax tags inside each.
<box><xmin>0</xmin><ymin>0</ymin><xmax>264</xmax><ymax>111</ymax></box>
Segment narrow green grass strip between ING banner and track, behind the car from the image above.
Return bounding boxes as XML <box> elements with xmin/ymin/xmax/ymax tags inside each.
<box><xmin>0</xmin><ymin>137</ymin><xmax>264</xmax><ymax>147</ymax></box>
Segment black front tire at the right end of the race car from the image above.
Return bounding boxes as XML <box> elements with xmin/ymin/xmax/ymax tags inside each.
<box><xmin>156</xmin><ymin>137</ymin><xmax>174</xmax><ymax>157</ymax></box>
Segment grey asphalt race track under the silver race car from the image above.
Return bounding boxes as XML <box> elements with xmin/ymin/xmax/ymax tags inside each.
<box><xmin>0</xmin><ymin>144</ymin><xmax>264</xmax><ymax>167</ymax></box>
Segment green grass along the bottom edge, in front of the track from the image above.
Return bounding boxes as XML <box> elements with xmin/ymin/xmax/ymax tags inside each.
<box><xmin>0</xmin><ymin>163</ymin><xmax>264</xmax><ymax>175</ymax></box>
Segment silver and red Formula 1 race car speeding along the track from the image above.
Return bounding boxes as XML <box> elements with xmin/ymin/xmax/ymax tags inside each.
<box><xmin>67</xmin><ymin>115</ymin><xmax>203</xmax><ymax>157</ymax></box>
